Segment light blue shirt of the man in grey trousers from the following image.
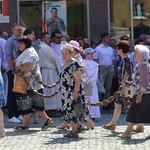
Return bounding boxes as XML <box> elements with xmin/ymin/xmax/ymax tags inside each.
<box><xmin>93</xmin><ymin>44</ymin><xmax>114</xmax><ymax>66</ymax></box>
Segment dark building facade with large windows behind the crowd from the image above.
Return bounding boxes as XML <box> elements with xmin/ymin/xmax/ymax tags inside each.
<box><xmin>0</xmin><ymin>0</ymin><xmax>150</xmax><ymax>40</ymax></box>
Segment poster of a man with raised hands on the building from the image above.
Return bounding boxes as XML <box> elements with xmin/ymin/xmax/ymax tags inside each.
<box><xmin>42</xmin><ymin>1</ymin><xmax>67</xmax><ymax>35</ymax></box>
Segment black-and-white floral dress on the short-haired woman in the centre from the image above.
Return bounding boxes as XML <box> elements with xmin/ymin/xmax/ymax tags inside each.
<box><xmin>60</xmin><ymin>61</ymin><xmax>90</xmax><ymax>123</ymax></box>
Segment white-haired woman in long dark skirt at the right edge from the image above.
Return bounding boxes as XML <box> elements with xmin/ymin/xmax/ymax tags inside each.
<box><xmin>122</xmin><ymin>45</ymin><xmax>150</xmax><ymax>138</ymax></box>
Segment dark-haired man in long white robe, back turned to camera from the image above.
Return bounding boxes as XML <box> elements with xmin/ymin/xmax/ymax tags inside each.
<box><xmin>38</xmin><ymin>33</ymin><xmax>62</xmax><ymax>110</ymax></box>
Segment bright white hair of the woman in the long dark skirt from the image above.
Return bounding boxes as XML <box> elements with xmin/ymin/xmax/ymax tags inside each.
<box><xmin>134</xmin><ymin>44</ymin><xmax>149</xmax><ymax>60</ymax></box>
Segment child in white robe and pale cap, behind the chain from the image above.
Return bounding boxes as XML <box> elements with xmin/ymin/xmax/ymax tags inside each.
<box><xmin>84</xmin><ymin>47</ymin><xmax>101</xmax><ymax>119</ymax></box>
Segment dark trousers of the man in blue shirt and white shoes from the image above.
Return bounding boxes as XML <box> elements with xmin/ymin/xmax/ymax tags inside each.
<box><xmin>7</xmin><ymin>70</ymin><xmax>20</xmax><ymax>118</ymax></box>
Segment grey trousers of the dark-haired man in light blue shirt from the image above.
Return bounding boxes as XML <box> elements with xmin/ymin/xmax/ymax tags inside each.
<box><xmin>99</xmin><ymin>65</ymin><xmax>114</xmax><ymax>99</ymax></box>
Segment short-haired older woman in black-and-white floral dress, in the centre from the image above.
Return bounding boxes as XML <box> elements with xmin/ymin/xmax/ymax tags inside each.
<box><xmin>60</xmin><ymin>44</ymin><xmax>92</xmax><ymax>137</ymax></box>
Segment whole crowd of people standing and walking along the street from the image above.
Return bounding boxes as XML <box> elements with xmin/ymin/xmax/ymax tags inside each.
<box><xmin>0</xmin><ymin>23</ymin><xmax>150</xmax><ymax>138</ymax></box>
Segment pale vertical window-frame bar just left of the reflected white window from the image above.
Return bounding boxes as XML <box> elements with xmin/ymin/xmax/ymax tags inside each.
<box><xmin>130</xmin><ymin>0</ymin><xmax>134</xmax><ymax>41</ymax></box>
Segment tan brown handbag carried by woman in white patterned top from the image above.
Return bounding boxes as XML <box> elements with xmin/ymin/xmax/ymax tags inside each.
<box><xmin>12</xmin><ymin>75</ymin><xmax>29</xmax><ymax>94</ymax></box>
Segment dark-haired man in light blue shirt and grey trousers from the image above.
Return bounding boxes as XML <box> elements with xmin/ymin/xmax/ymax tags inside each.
<box><xmin>93</xmin><ymin>33</ymin><xmax>114</xmax><ymax>107</ymax></box>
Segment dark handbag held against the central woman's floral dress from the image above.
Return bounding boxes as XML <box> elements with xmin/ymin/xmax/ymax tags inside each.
<box><xmin>73</xmin><ymin>97</ymin><xmax>85</xmax><ymax>117</ymax></box>
